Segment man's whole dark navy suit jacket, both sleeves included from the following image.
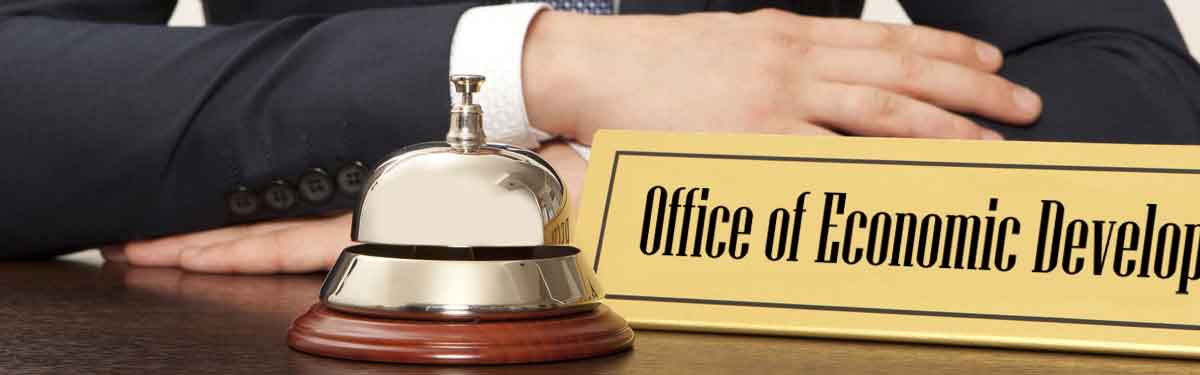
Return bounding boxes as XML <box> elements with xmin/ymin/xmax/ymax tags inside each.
<box><xmin>0</xmin><ymin>0</ymin><xmax>1200</xmax><ymax>257</ymax></box>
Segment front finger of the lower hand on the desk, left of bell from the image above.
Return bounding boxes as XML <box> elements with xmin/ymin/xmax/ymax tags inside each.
<box><xmin>179</xmin><ymin>215</ymin><xmax>352</xmax><ymax>274</ymax></box>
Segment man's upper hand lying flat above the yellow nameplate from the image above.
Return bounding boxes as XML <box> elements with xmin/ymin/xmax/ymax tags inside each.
<box><xmin>523</xmin><ymin>10</ymin><xmax>1042</xmax><ymax>143</ymax></box>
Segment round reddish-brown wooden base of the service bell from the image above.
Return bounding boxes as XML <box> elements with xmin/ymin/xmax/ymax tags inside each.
<box><xmin>288</xmin><ymin>303</ymin><xmax>634</xmax><ymax>364</ymax></box>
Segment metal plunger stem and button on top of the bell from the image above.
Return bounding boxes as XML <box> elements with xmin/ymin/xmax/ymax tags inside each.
<box><xmin>446</xmin><ymin>75</ymin><xmax>487</xmax><ymax>153</ymax></box>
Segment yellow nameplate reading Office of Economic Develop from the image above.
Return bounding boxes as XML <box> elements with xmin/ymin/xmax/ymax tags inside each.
<box><xmin>574</xmin><ymin>131</ymin><xmax>1200</xmax><ymax>358</ymax></box>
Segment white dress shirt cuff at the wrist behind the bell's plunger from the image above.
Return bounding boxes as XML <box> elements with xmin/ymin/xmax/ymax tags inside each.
<box><xmin>450</xmin><ymin>2</ymin><xmax>550</xmax><ymax>149</ymax></box>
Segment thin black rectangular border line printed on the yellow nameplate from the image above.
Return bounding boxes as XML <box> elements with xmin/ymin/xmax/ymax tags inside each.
<box><xmin>592</xmin><ymin>150</ymin><xmax>1200</xmax><ymax>331</ymax></box>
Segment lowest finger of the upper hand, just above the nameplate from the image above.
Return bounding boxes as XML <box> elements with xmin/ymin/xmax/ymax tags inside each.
<box><xmin>798</xmin><ymin>83</ymin><xmax>1003</xmax><ymax>139</ymax></box>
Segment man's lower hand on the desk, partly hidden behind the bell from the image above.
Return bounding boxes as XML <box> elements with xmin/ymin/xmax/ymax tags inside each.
<box><xmin>101</xmin><ymin>143</ymin><xmax>587</xmax><ymax>274</ymax></box>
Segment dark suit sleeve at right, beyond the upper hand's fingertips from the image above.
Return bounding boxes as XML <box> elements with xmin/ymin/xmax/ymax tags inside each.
<box><xmin>901</xmin><ymin>0</ymin><xmax>1200</xmax><ymax>144</ymax></box>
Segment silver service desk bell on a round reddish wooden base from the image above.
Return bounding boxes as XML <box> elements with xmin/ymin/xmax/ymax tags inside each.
<box><xmin>288</xmin><ymin>76</ymin><xmax>634</xmax><ymax>364</ymax></box>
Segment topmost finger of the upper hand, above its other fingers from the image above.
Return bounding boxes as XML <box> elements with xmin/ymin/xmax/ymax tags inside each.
<box><xmin>763</xmin><ymin>11</ymin><xmax>1004</xmax><ymax>72</ymax></box>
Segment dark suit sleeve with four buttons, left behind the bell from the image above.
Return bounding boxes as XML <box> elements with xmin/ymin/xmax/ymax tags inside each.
<box><xmin>0</xmin><ymin>0</ymin><xmax>473</xmax><ymax>258</ymax></box>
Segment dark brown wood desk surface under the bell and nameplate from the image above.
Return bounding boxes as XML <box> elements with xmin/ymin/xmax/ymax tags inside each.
<box><xmin>0</xmin><ymin>257</ymin><xmax>1200</xmax><ymax>375</ymax></box>
